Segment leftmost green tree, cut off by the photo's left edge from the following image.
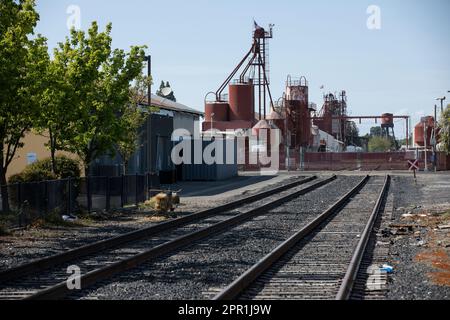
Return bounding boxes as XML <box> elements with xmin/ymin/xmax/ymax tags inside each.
<box><xmin>0</xmin><ymin>0</ymin><xmax>48</xmax><ymax>211</ymax></box>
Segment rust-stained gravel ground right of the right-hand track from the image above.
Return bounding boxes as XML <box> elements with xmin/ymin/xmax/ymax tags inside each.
<box><xmin>387</xmin><ymin>176</ymin><xmax>450</xmax><ymax>300</ymax></box>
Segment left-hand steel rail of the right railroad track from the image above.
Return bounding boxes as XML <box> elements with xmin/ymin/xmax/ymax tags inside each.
<box><xmin>213</xmin><ymin>176</ymin><xmax>370</xmax><ymax>300</ymax></box>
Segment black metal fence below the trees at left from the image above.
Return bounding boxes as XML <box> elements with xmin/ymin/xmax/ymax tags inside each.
<box><xmin>0</xmin><ymin>174</ymin><xmax>160</xmax><ymax>224</ymax></box>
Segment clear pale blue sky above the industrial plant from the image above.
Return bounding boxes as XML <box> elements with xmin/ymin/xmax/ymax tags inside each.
<box><xmin>37</xmin><ymin>0</ymin><xmax>450</xmax><ymax>135</ymax></box>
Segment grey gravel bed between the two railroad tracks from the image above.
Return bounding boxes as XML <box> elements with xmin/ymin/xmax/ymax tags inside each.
<box><xmin>72</xmin><ymin>177</ymin><xmax>361</xmax><ymax>300</ymax></box>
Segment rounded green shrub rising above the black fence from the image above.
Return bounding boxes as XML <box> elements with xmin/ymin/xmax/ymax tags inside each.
<box><xmin>9</xmin><ymin>156</ymin><xmax>81</xmax><ymax>184</ymax></box>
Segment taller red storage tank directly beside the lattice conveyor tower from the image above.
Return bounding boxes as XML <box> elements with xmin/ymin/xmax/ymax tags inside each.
<box><xmin>229</xmin><ymin>83</ymin><xmax>255</xmax><ymax>121</ymax></box>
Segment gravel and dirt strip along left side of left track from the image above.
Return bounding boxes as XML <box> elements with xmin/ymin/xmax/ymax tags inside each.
<box><xmin>0</xmin><ymin>175</ymin><xmax>306</xmax><ymax>270</ymax></box>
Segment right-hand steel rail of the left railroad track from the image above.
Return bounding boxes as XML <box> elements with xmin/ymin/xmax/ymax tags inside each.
<box><xmin>23</xmin><ymin>176</ymin><xmax>337</xmax><ymax>300</ymax></box>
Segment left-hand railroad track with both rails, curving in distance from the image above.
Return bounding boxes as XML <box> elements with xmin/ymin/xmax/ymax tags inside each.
<box><xmin>0</xmin><ymin>176</ymin><xmax>336</xmax><ymax>299</ymax></box>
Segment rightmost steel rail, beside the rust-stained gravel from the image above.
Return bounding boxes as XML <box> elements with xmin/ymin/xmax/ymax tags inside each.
<box><xmin>336</xmin><ymin>175</ymin><xmax>391</xmax><ymax>300</ymax></box>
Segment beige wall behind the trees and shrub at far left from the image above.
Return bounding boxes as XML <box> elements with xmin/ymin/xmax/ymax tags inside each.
<box><xmin>6</xmin><ymin>132</ymin><xmax>83</xmax><ymax>179</ymax></box>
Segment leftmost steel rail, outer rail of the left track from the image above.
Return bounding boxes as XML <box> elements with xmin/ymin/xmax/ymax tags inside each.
<box><xmin>0</xmin><ymin>176</ymin><xmax>317</xmax><ymax>283</ymax></box>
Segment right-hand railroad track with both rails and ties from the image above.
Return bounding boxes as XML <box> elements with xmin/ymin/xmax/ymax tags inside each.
<box><xmin>214</xmin><ymin>176</ymin><xmax>390</xmax><ymax>300</ymax></box>
